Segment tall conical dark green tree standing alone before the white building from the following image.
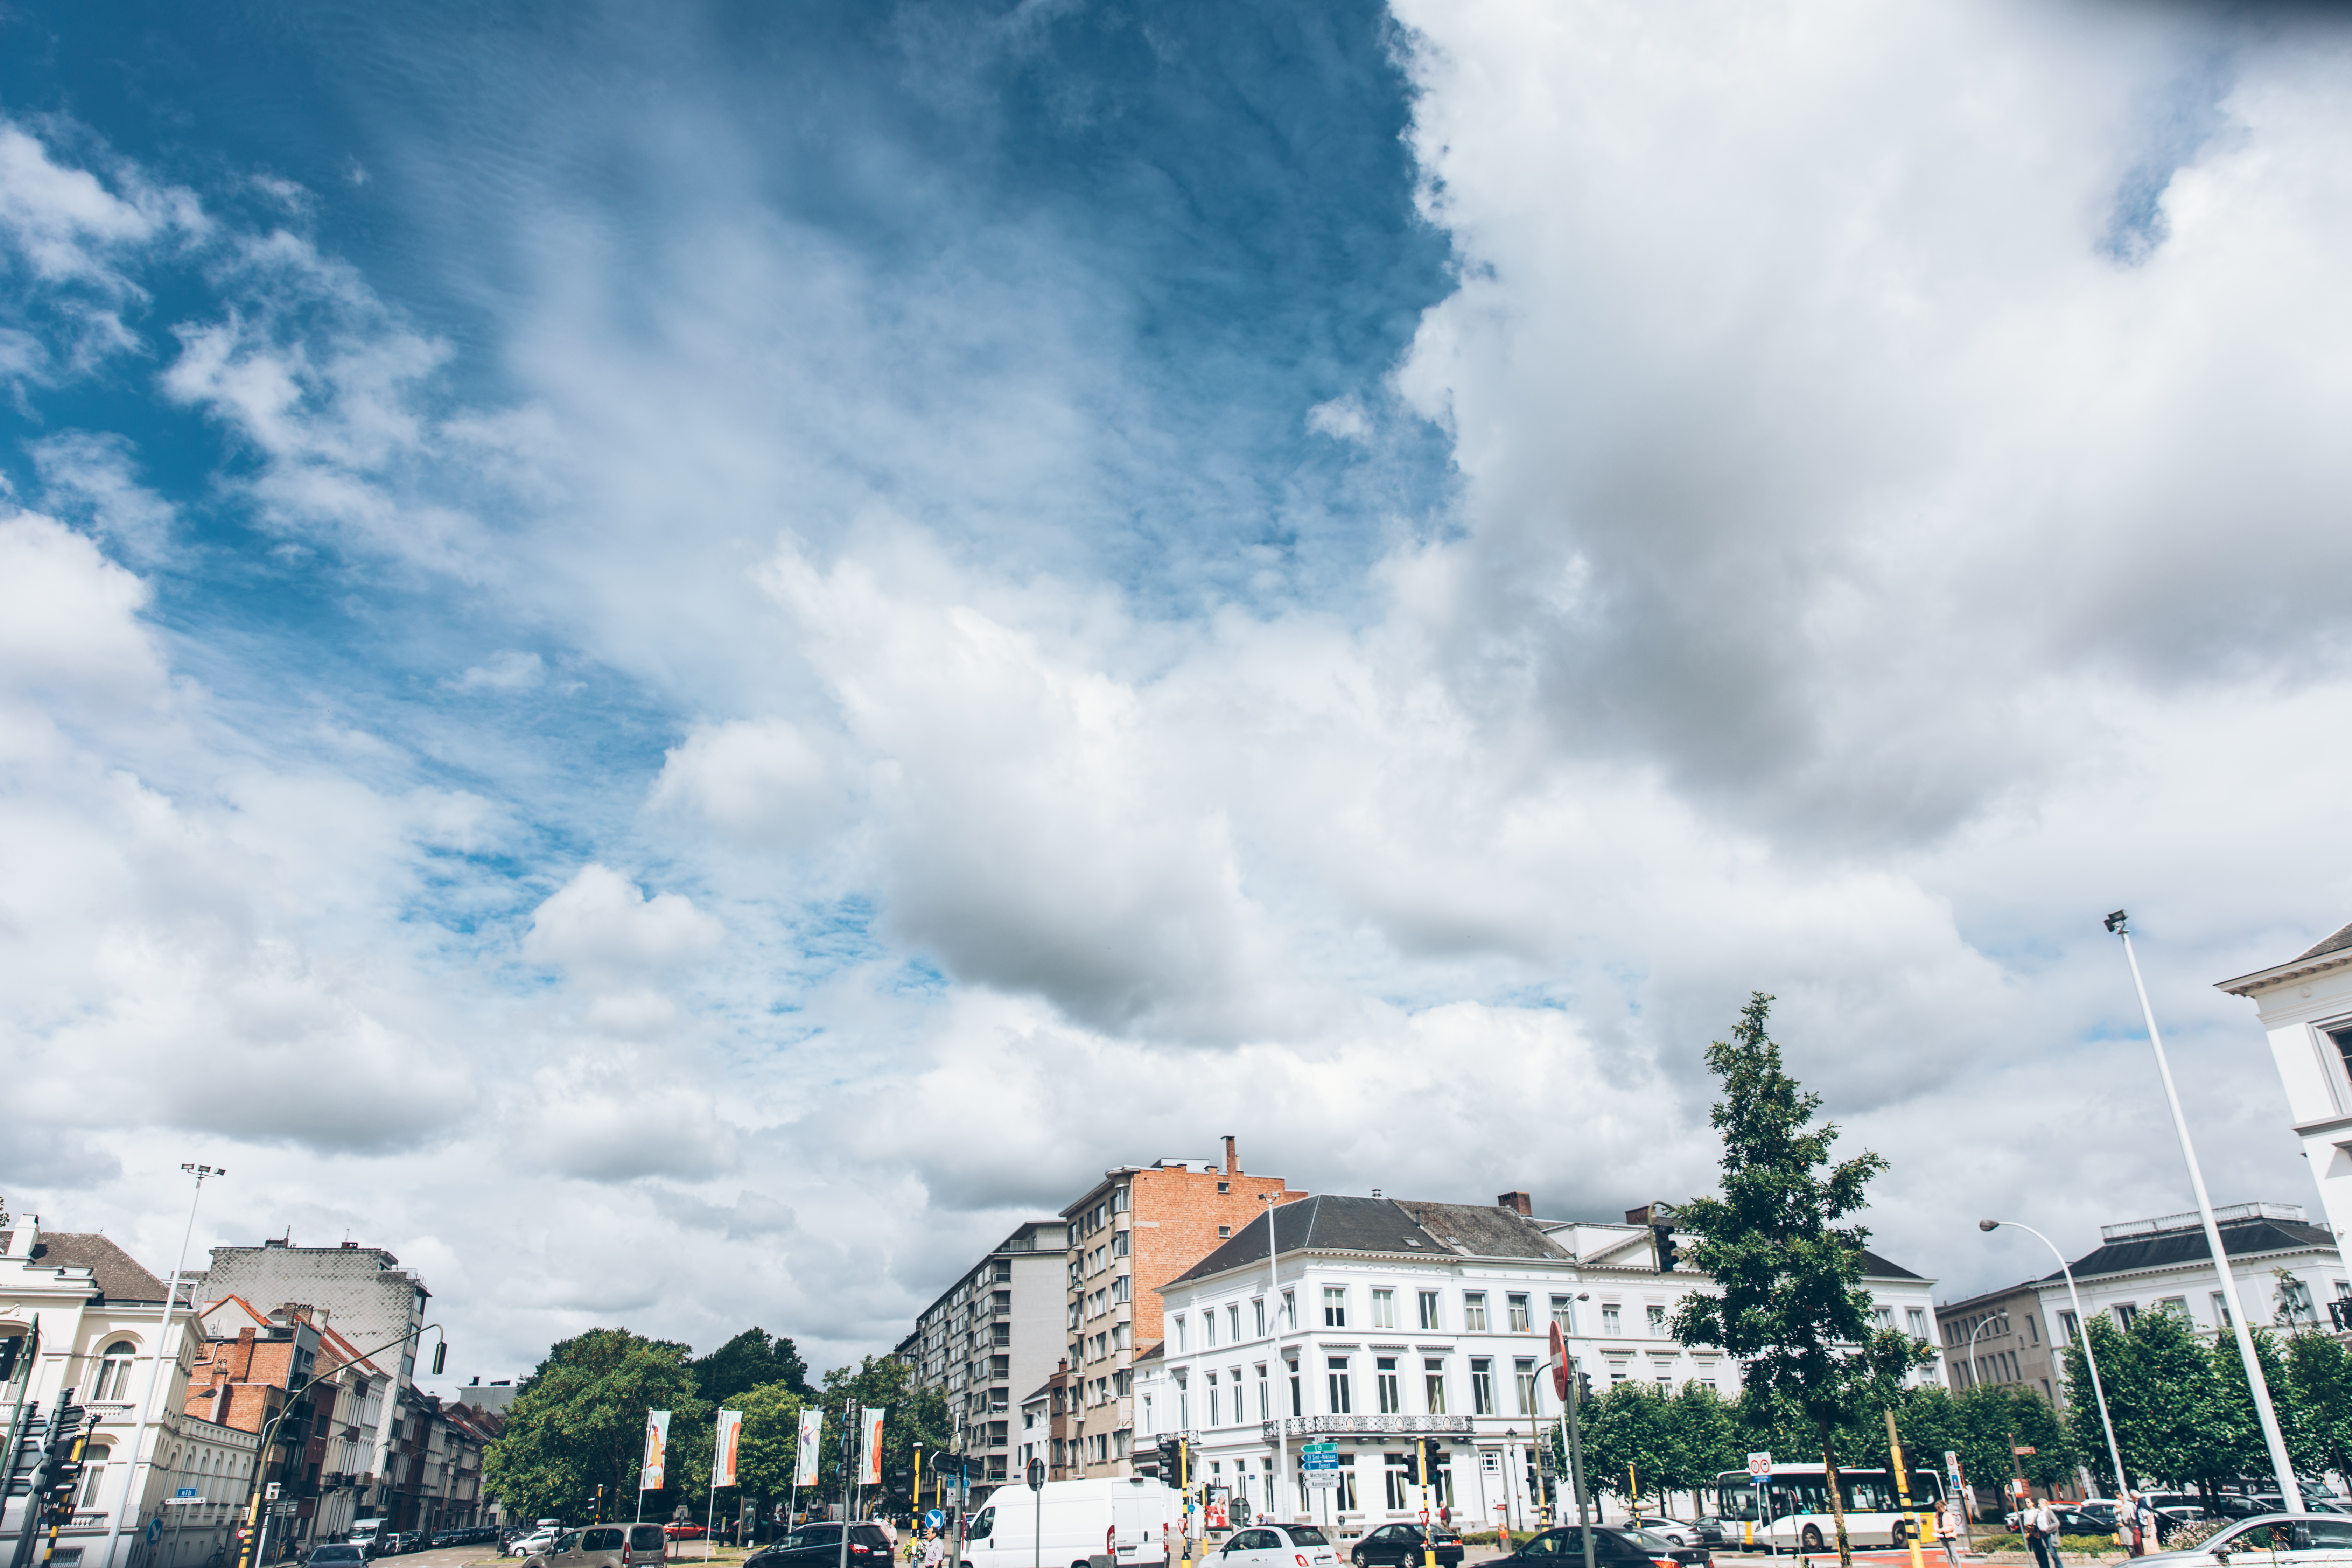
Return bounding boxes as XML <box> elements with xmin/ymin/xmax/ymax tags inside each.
<box><xmin>1675</xmin><ymin>992</ymin><xmax>1933</xmax><ymax>1568</ymax></box>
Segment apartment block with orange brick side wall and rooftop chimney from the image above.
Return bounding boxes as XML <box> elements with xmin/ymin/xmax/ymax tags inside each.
<box><xmin>1046</xmin><ymin>1138</ymin><xmax>1308</xmax><ymax>1479</ymax></box>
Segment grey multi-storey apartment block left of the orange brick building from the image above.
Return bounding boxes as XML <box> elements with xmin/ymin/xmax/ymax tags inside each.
<box><xmin>896</xmin><ymin>1220</ymin><xmax>1070</xmax><ymax>1502</ymax></box>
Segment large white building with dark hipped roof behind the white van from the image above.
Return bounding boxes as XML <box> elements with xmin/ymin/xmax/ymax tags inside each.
<box><xmin>1136</xmin><ymin>1192</ymin><xmax>1940</xmax><ymax>1535</ymax></box>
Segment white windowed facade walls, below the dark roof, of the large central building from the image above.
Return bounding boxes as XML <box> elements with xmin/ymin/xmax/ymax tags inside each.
<box><xmin>1136</xmin><ymin>1227</ymin><xmax>1943</xmax><ymax>1535</ymax></box>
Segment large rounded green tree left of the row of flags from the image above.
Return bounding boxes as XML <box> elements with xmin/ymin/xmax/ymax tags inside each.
<box><xmin>482</xmin><ymin>1328</ymin><xmax>708</xmax><ymax>1519</ymax></box>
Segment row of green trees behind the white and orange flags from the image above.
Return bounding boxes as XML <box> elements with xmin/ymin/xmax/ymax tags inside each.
<box><xmin>482</xmin><ymin>1328</ymin><xmax>950</xmax><ymax>1519</ymax></box>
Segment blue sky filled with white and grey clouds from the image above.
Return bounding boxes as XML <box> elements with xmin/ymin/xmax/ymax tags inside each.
<box><xmin>0</xmin><ymin>0</ymin><xmax>2352</xmax><ymax>1380</ymax></box>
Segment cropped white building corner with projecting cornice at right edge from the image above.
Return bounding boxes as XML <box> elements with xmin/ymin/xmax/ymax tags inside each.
<box><xmin>2220</xmin><ymin>926</ymin><xmax>2352</xmax><ymax>1260</ymax></box>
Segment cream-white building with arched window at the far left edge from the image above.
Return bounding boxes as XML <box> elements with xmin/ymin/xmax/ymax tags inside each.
<box><xmin>0</xmin><ymin>1216</ymin><xmax>256</xmax><ymax>1568</ymax></box>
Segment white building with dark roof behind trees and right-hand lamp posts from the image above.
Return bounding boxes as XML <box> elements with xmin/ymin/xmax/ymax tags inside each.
<box><xmin>2037</xmin><ymin>1204</ymin><xmax>2352</xmax><ymax>1345</ymax></box>
